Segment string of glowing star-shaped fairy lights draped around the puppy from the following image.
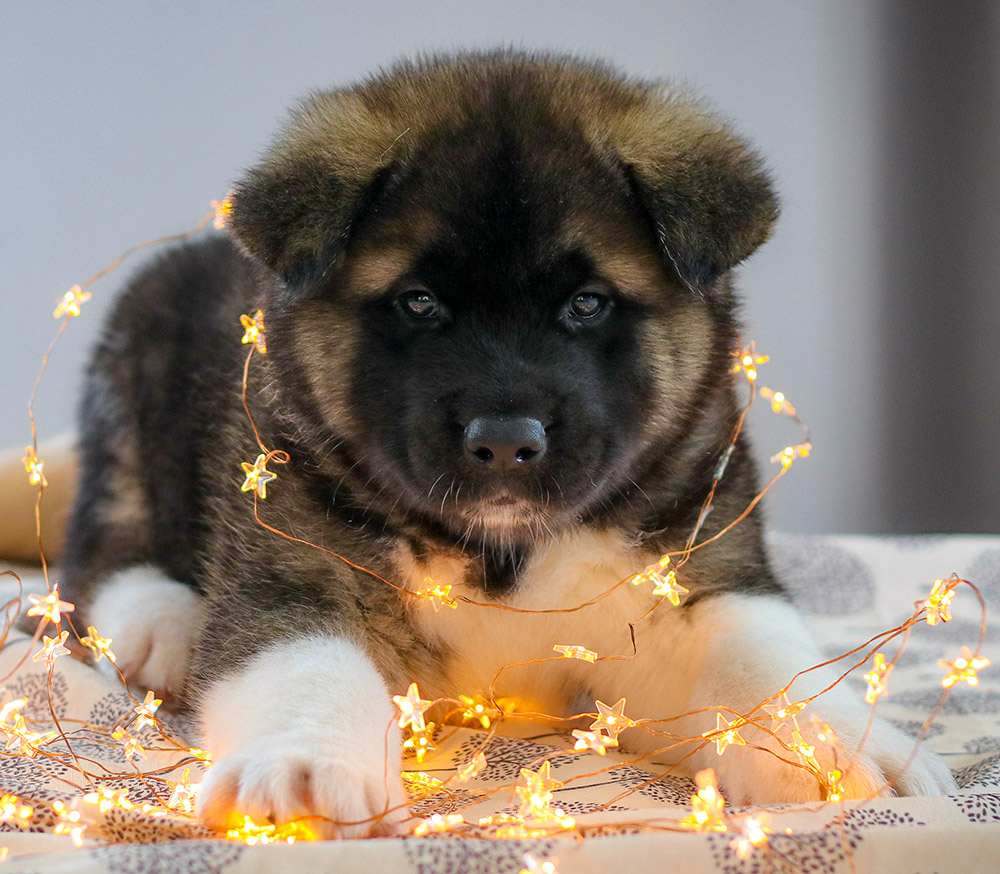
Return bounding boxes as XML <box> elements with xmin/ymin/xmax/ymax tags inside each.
<box><xmin>0</xmin><ymin>198</ymin><xmax>990</xmax><ymax>874</ymax></box>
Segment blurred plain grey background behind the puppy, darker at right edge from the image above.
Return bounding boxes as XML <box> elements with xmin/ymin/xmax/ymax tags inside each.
<box><xmin>0</xmin><ymin>0</ymin><xmax>1000</xmax><ymax>533</ymax></box>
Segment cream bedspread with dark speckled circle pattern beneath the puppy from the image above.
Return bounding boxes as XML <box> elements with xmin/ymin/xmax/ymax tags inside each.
<box><xmin>0</xmin><ymin>535</ymin><xmax>1000</xmax><ymax>874</ymax></box>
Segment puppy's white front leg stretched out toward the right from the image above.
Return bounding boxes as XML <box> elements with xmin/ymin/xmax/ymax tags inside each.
<box><xmin>672</xmin><ymin>595</ymin><xmax>955</xmax><ymax>804</ymax></box>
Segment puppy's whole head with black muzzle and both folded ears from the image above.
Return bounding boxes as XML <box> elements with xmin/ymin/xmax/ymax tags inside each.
<box><xmin>234</xmin><ymin>56</ymin><xmax>774</xmax><ymax>541</ymax></box>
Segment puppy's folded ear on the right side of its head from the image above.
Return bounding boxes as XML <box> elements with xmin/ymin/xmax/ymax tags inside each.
<box><xmin>614</xmin><ymin>88</ymin><xmax>778</xmax><ymax>285</ymax></box>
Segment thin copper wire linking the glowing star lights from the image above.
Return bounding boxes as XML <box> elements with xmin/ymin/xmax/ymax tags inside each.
<box><xmin>0</xmin><ymin>209</ymin><xmax>987</xmax><ymax>870</ymax></box>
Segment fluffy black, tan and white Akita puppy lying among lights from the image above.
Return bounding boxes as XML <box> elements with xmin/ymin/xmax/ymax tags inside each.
<box><xmin>56</xmin><ymin>52</ymin><xmax>954</xmax><ymax>835</ymax></box>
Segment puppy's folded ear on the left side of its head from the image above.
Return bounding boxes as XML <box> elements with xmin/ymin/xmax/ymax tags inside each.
<box><xmin>229</xmin><ymin>92</ymin><xmax>391</xmax><ymax>295</ymax></box>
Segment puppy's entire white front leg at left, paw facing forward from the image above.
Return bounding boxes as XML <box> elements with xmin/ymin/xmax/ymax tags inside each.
<box><xmin>191</xmin><ymin>617</ymin><xmax>409</xmax><ymax>837</ymax></box>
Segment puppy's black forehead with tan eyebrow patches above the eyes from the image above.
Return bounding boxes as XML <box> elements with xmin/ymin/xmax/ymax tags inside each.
<box><xmin>346</xmin><ymin>130</ymin><xmax>666</xmax><ymax>301</ymax></box>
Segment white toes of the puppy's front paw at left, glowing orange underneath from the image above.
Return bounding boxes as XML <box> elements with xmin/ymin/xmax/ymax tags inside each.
<box><xmin>198</xmin><ymin>730</ymin><xmax>410</xmax><ymax>838</ymax></box>
